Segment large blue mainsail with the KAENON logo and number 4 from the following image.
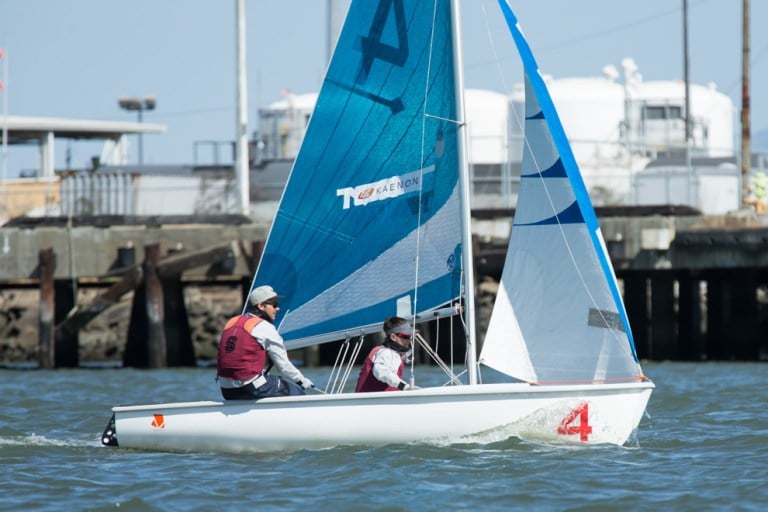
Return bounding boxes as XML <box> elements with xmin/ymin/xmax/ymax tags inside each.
<box><xmin>252</xmin><ymin>0</ymin><xmax>461</xmax><ymax>348</ymax></box>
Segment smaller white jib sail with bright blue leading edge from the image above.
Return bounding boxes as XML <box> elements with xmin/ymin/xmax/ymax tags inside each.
<box><xmin>480</xmin><ymin>0</ymin><xmax>642</xmax><ymax>382</ymax></box>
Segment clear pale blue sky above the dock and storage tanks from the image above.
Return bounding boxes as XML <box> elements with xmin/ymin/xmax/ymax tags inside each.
<box><xmin>0</xmin><ymin>0</ymin><xmax>768</xmax><ymax>177</ymax></box>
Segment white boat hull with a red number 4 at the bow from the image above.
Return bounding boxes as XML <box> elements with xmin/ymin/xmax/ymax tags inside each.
<box><xmin>103</xmin><ymin>382</ymin><xmax>654</xmax><ymax>453</ymax></box>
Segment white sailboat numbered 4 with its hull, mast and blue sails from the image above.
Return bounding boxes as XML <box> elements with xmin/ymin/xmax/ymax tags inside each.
<box><xmin>102</xmin><ymin>0</ymin><xmax>654</xmax><ymax>452</ymax></box>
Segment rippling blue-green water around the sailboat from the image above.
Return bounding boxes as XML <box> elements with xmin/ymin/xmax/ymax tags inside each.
<box><xmin>0</xmin><ymin>363</ymin><xmax>768</xmax><ymax>511</ymax></box>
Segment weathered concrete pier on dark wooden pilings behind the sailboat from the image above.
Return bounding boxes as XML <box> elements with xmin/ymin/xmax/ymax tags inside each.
<box><xmin>0</xmin><ymin>211</ymin><xmax>768</xmax><ymax>368</ymax></box>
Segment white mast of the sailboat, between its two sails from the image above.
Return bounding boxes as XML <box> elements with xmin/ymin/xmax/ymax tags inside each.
<box><xmin>451</xmin><ymin>0</ymin><xmax>477</xmax><ymax>384</ymax></box>
